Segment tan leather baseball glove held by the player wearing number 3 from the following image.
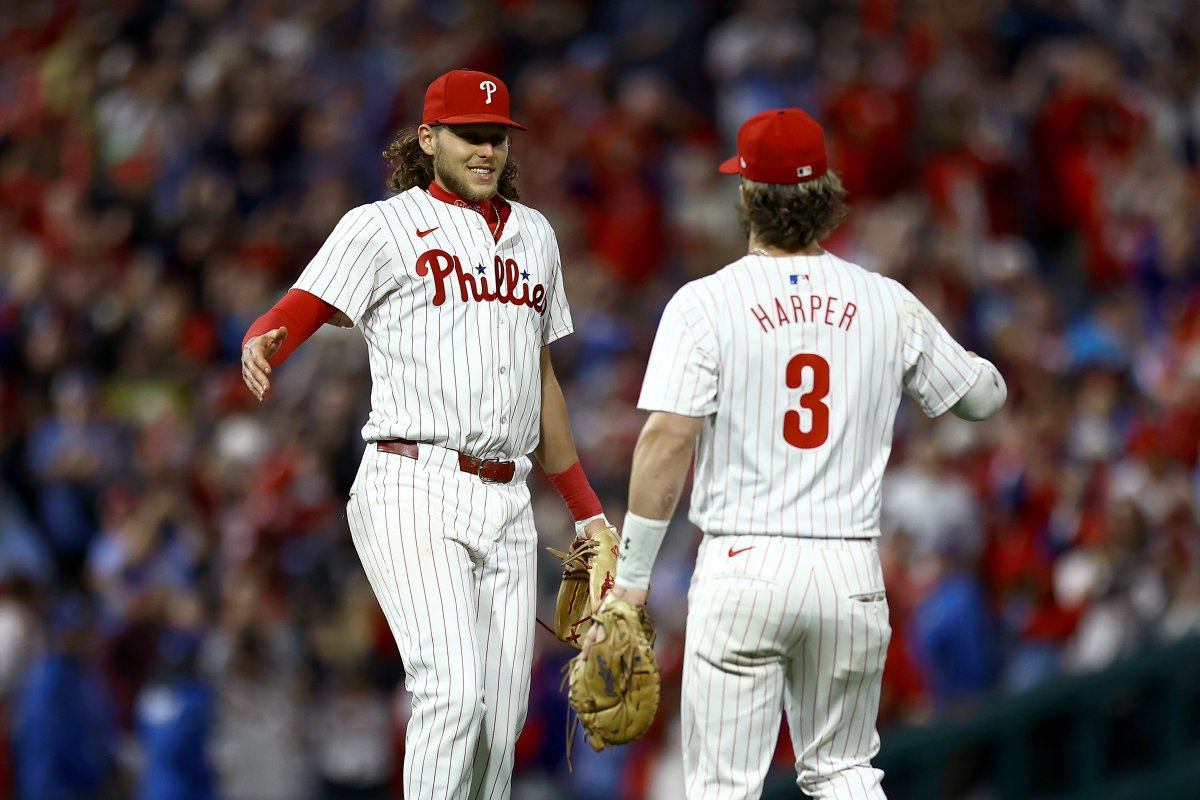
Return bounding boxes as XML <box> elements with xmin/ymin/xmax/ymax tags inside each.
<box><xmin>566</xmin><ymin>595</ymin><xmax>659</xmax><ymax>751</ymax></box>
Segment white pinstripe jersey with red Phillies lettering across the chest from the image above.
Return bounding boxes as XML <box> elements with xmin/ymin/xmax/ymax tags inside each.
<box><xmin>295</xmin><ymin>188</ymin><xmax>572</xmax><ymax>458</ymax></box>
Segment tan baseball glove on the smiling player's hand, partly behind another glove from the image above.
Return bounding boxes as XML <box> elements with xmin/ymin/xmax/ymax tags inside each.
<box><xmin>546</xmin><ymin>527</ymin><xmax>620</xmax><ymax>650</ymax></box>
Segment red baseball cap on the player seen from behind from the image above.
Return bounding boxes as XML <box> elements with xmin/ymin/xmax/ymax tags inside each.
<box><xmin>718</xmin><ymin>108</ymin><xmax>829</xmax><ymax>184</ymax></box>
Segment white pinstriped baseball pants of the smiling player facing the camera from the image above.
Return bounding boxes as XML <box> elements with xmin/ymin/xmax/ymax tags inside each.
<box><xmin>347</xmin><ymin>444</ymin><xmax>538</xmax><ymax>800</ymax></box>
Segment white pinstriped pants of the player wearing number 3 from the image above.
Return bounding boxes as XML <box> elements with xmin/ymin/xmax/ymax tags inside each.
<box><xmin>682</xmin><ymin>536</ymin><xmax>892</xmax><ymax>800</ymax></box>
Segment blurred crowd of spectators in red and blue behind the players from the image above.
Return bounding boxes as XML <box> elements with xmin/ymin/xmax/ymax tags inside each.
<box><xmin>0</xmin><ymin>0</ymin><xmax>1200</xmax><ymax>800</ymax></box>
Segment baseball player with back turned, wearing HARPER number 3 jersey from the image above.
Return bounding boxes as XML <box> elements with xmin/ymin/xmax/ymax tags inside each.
<box><xmin>589</xmin><ymin>108</ymin><xmax>1007</xmax><ymax>800</ymax></box>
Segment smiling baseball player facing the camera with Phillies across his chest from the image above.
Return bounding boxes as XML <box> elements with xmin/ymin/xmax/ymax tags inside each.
<box><xmin>242</xmin><ymin>70</ymin><xmax>607</xmax><ymax>800</ymax></box>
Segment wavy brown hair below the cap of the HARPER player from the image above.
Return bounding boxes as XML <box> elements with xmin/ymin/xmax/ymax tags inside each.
<box><xmin>738</xmin><ymin>169</ymin><xmax>846</xmax><ymax>253</ymax></box>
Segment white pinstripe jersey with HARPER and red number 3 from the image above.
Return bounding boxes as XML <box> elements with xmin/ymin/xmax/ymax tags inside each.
<box><xmin>638</xmin><ymin>253</ymin><xmax>980</xmax><ymax>537</ymax></box>
